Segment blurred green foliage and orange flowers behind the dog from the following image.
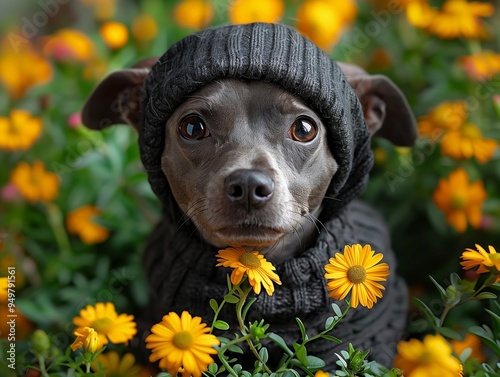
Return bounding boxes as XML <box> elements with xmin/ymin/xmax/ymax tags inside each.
<box><xmin>0</xmin><ymin>0</ymin><xmax>500</xmax><ymax>376</ymax></box>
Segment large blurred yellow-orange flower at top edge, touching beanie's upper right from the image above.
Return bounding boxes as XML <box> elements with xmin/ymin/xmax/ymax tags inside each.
<box><xmin>297</xmin><ymin>0</ymin><xmax>357</xmax><ymax>51</ymax></box>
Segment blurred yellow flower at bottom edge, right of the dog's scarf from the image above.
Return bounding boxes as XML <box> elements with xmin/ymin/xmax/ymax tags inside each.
<box><xmin>394</xmin><ymin>335</ymin><xmax>463</xmax><ymax>377</ymax></box>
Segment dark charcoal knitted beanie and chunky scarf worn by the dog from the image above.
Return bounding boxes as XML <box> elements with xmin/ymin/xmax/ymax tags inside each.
<box><xmin>139</xmin><ymin>23</ymin><xmax>406</xmax><ymax>368</ymax></box>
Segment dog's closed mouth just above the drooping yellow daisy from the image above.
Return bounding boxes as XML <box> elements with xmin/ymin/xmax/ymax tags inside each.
<box><xmin>215</xmin><ymin>225</ymin><xmax>286</xmax><ymax>247</ymax></box>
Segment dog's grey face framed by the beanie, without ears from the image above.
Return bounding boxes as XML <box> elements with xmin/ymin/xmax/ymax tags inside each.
<box><xmin>162</xmin><ymin>79</ymin><xmax>337</xmax><ymax>260</ymax></box>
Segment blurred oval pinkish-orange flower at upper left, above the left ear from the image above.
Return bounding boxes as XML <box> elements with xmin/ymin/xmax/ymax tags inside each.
<box><xmin>43</xmin><ymin>29</ymin><xmax>94</xmax><ymax>62</ymax></box>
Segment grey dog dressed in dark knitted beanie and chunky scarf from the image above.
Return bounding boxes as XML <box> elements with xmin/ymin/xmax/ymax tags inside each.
<box><xmin>82</xmin><ymin>23</ymin><xmax>416</xmax><ymax>368</ymax></box>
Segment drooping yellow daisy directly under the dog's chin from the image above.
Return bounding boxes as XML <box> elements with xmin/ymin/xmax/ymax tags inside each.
<box><xmin>216</xmin><ymin>246</ymin><xmax>281</xmax><ymax>296</ymax></box>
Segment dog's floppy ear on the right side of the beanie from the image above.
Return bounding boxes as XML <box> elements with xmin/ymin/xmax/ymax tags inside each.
<box><xmin>338</xmin><ymin>63</ymin><xmax>417</xmax><ymax>146</ymax></box>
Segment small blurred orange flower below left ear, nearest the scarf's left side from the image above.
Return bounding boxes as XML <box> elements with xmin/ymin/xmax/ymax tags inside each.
<box><xmin>66</xmin><ymin>205</ymin><xmax>109</xmax><ymax>245</ymax></box>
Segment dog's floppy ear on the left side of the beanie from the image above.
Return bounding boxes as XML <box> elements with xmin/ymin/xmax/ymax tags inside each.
<box><xmin>82</xmin><ymin>57</ymin><xmax>158</xmax><ymax>130</ymax></box>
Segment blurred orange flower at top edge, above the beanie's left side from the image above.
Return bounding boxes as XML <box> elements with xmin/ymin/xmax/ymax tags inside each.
<box><xmin>174</xmin><ymin>0</ymin><xmax>214</xmax><ymax>30</ymax></box>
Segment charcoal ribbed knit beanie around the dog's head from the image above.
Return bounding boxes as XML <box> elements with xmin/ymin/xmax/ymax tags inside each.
<box><xmin>139</xmin><ymin>23</ymin><xmax>373</xmax><ymax>217</ymax></box>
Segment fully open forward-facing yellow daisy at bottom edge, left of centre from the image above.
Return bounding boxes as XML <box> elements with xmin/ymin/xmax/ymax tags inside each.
<box><xmin>146</xmin><ymin>311</ymin><xmax>220</xmax><ymax>377</ymax></box>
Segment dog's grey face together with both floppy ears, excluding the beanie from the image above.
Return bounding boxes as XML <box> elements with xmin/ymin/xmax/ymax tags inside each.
<box><xmin>82</xmin><ymin>58</ymin><xmax>416</xmax><ymax>262</ymax></box>
